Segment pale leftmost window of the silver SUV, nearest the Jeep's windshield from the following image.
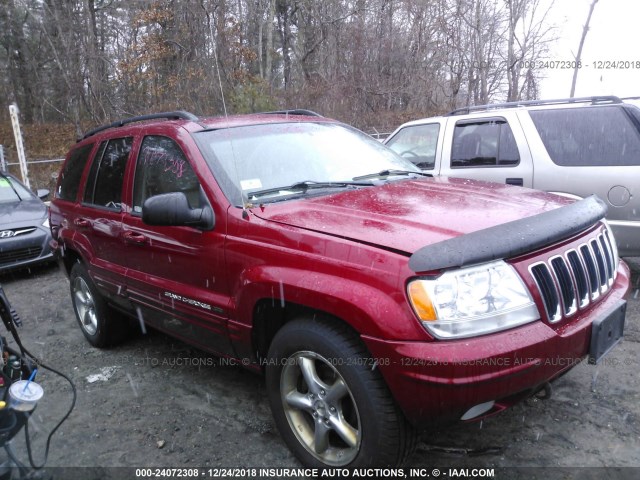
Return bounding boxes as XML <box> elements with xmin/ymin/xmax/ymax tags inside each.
<box><xmin>386</xmin><ymin>123</ymin><xmax>440</xmax><ymax>170</ymax></box>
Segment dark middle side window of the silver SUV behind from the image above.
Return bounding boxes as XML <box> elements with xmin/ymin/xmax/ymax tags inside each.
<box><xmin>451</xmin><ymin>118</ymin><xmax>520</xmax><ymax>168</ymax></box>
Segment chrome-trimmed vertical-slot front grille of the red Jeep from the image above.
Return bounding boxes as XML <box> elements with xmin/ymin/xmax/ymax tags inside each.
<box><xmin>529</xmin><ymin>230</ymin><xmax>617</xmax><ymax>323</ymax></box>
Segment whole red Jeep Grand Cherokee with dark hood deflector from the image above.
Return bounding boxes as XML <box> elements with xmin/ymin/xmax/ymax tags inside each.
<box><xmin>51</xmin><ymin>111</ymin><xmax>629</xmax><ymax>468</ymax></box>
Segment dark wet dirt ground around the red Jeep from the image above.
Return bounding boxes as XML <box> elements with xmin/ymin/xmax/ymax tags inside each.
<box><xmin>0</xmin><ymin>259</ymin><xmax>640</xmax><ymax>478</ymax></box>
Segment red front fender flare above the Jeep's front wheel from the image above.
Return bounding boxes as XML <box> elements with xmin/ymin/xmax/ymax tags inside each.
<box><xmin>234</xmin><ymin>267</ymin><xmax>424</xmax><ymax>368</ymax></box>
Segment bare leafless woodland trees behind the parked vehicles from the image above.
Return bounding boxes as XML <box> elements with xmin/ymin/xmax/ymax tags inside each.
<box><xmin>0</xmin><ymin>0</ymin><xmax>553</xmax><ymax>132</ymax></box>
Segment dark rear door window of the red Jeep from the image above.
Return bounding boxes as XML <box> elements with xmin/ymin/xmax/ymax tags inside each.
<box><xmin>84</xmin><ymin>137</ymin><xmax>133</xmax><ymax>210</ymax></box>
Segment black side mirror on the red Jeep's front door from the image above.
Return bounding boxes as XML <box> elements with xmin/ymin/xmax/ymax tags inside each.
<box><xmin>142</xmin><ymin>192</ymin><xmax>215</xmax><ymax>230</ymax></box>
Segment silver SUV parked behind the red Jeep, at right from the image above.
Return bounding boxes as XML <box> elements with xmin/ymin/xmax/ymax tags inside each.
<box><xmin>384</xmin><ymin>97</ymin><xmax>640</xmax><ymax>256</ymax></box>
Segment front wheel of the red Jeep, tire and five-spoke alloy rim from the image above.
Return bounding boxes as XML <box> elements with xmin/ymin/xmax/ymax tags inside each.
<box><xmin>266</xmin><ymin>319</ymin><xmax>415</xmax><ymax>468</ymax></box>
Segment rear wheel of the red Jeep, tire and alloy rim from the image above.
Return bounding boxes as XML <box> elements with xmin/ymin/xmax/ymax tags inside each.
<box><xmin>69</xmin><ymin>262</ymin><xmax>128</xmax><ymax>348</ymax></box>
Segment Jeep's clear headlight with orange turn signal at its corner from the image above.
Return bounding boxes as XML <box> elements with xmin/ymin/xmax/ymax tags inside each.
<box><xmin>407</xmin><ymin>261</ymin><xmax>540</xmax><ymax>339</ymax></box>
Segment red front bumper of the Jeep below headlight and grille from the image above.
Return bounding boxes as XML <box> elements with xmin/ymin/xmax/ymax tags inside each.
<box><xmin>363</xmin><ymin>262</ymin><xmax>630</xmax><ymax>427</ymax></box>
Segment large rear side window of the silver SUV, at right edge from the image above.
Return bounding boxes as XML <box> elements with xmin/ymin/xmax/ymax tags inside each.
<box><xmin>529</xmin><ymin>107</ymin><xmax>640</xmax><ymax>167</ymax></box>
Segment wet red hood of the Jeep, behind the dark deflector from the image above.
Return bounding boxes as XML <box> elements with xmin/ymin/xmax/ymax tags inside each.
<box><xmin>252</xmin><ymin>177</ymin><xmax>573</xmax><ymax>255</ymax></box>
